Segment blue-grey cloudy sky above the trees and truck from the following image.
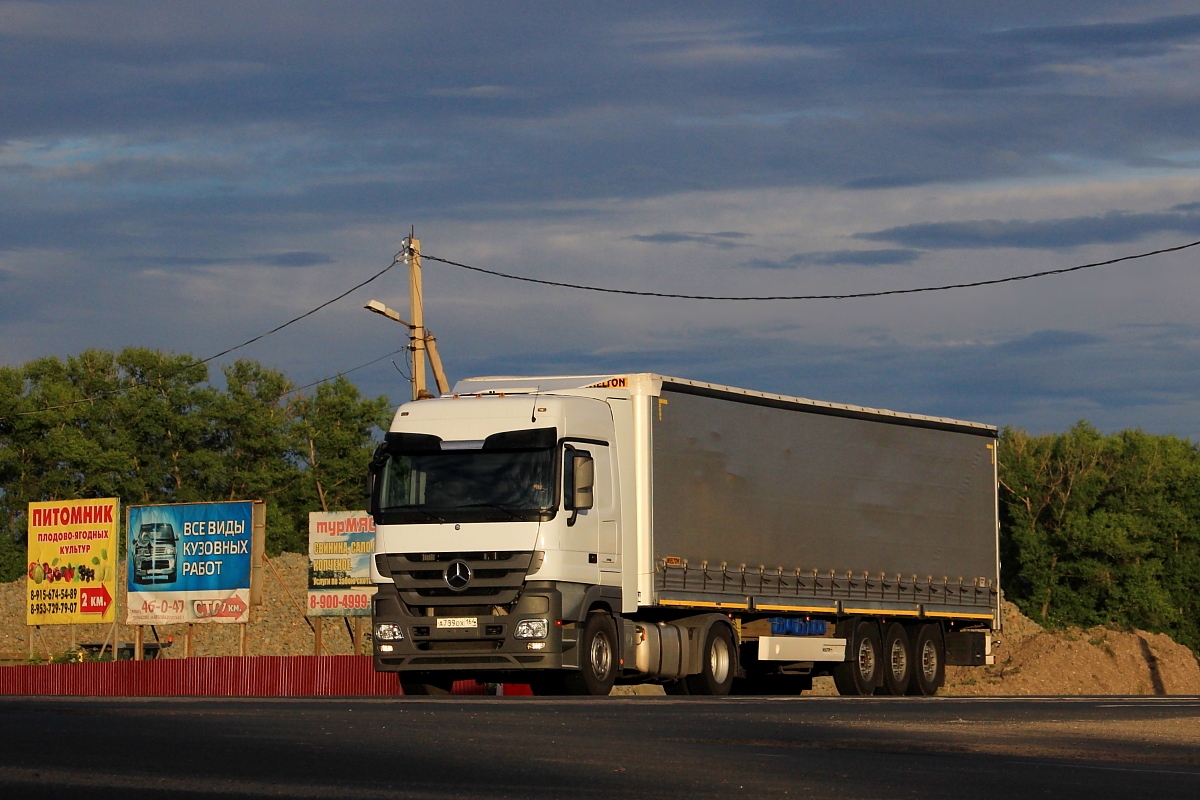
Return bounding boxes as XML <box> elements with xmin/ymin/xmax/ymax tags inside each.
<box><xmin>0</xmin><ymin>0</ymin><xmax>1200</xmax><ymax>440</ymax></box>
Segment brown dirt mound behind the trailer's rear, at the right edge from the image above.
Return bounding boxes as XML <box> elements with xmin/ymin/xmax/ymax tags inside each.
<box><xmin>943</xmin><ymin>602</ymin><xmax>1200</xmax><ymax>694</ymax></box>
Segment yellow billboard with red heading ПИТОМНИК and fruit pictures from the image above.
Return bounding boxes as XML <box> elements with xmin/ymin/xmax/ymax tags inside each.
<box><xmin>25</xmin><ymin>498</ymin><xmax>120</xmax><ymax>625</ymax></box>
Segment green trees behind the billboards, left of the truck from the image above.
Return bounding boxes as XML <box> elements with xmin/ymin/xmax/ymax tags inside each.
<box><xmin>0</xmin><ymin>348</ymin><xmax>389</xmax><ymax>581</ymax></box>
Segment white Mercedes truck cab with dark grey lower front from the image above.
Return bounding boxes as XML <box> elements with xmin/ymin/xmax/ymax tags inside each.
<box><xmin>371</xmin><ymin>387</ymin><xmax>623</xmax><ymax>691</ymax></box>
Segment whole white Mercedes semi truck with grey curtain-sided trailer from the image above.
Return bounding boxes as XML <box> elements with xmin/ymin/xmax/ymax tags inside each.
<box><xmin>368</xmin><ymin>373</ymin><xmax>1001</xmax><ymax>694</ymax></box>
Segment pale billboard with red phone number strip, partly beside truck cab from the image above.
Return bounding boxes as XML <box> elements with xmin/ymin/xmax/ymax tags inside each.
<box><xmin>308</xmin><ymin>511</ymin><xmax>376</xmax><ymax>616</ymax></box>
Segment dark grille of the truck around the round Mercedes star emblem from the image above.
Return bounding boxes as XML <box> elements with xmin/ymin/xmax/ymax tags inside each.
<box><xmin>376</xmin><ymin>552</ymin><xmax>533</xmax><ymax>606</ymax></box>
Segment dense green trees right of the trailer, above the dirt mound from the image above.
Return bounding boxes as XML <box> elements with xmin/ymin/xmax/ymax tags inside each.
<box><xmin>998</xmin><ymin>422</ymin><xmax>1200</xmax><ymax>649</ymax></box>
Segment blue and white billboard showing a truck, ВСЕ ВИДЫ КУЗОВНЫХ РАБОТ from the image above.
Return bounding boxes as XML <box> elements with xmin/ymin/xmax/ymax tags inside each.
<box><xmin>125</xmin><ymin>500</ymin><xmax>264</xmax><ymax>625</ymax></box>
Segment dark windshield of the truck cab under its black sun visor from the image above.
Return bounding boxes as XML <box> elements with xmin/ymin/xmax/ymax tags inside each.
<box><xmin>372</xmin><ymin>428</ymin><xmax>557</xmax><ymax>525</ymax></box>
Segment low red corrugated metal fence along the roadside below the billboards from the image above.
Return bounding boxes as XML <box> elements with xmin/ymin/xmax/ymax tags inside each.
<box><xmin>0</xmin><ymin>656</ymin><xmax>528</xmax><ymax>697</ymax></box>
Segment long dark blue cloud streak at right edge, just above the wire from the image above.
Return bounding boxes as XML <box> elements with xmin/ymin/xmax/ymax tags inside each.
<box><xmin>854</xmin><ymin>203</ymin><xmax>1200</xmax><ymax>249</ymax></box>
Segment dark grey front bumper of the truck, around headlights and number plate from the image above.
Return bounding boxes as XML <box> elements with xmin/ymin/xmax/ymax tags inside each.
<box><xmin>372</xmin><ymin>582</ymin><xmax>578</xmax><ymax>673</ymax></box>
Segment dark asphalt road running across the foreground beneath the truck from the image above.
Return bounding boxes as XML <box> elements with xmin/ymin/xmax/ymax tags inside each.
<box><xmin>0</xmin><ymin>697</ymin><xmax>1200</xmax><ymax>800</ymax></box>
